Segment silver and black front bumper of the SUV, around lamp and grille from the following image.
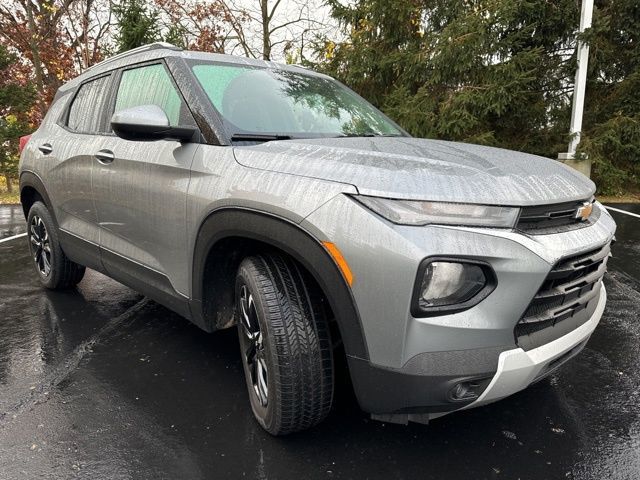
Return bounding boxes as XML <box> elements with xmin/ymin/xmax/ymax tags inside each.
<box><xmin>303</xmin><ymin>196</ymin><xmax>615</xmax><ymax>416</ymax></box>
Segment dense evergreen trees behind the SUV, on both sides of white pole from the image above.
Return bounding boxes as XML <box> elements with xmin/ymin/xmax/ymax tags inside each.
<box><xmin>316</xmin><ymin>0</ymin><xmax>640</xmax><ymax>193</ymax></box>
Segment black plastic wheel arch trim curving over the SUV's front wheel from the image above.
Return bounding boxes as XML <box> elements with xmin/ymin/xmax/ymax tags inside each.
<box><xmin>191</xmin><ymin>207</ymin><xmax>369</xmax><ymax>360</ymax></box>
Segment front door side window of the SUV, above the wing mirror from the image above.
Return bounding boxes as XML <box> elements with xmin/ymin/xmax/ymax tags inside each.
<box><xmin>115</xmin><ymin>64</ymin><xmax>186</xmax><ymax>126</ymax></box>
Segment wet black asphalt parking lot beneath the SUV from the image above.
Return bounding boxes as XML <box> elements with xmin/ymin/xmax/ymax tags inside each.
<box><xmin>0</xmin><ymin>205</ymin><xmax>640</xmax><ymax>479</ymax></box>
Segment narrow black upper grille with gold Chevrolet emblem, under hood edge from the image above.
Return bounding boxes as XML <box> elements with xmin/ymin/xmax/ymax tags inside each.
<box><xmin>516</xmin><ymin>201</ymin><xmax>600</xmax><ymax>234</ymax></box>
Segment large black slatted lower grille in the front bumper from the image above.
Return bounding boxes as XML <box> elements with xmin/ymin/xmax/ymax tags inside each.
<box><xmin>515</xmin><ymin>244</ymin><xmax>611</xmax><ymax>350</ymax></box>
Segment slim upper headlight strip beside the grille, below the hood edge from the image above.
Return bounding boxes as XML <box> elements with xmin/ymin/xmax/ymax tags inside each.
<box><xmin>353</xmin><ymin>195</ymin><xmax>520</xmax><ymax>228</ymax></box>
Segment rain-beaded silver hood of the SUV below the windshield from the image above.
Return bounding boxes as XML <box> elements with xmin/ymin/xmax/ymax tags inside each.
<box><xmin>234</xmin><ymin>137</ymin><xmax>595</xmax><ymax>206</ymax></box>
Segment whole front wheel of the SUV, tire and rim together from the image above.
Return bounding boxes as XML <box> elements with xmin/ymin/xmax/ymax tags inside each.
<box><xmin>236</xmin><ymin>254</ymin><xmax>333</xmax><ymax>435</ymax></box>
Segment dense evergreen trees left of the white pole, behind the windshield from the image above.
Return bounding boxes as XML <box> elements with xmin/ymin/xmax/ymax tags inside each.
<box><xmin>321</xmin><ymin>0</ymin><xmax>577</xmax><ymax>156</ymax></box>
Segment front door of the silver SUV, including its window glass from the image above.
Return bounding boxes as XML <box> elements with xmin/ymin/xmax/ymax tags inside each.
<box><xmin>93</xmin><ymin>62</ymin><xmax>198</xmax><ymax>299</ymax></box>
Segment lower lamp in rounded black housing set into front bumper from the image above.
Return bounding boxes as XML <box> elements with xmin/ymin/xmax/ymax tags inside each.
<box><xmin>412</xmin><ymin>258</ymin><xmax>497</xmax><ymax>316</ymax></box>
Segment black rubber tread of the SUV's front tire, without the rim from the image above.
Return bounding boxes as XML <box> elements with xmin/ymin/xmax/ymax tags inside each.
<box><xmin>240</xmin><ymin>254</ymin><xmax>333</xmax><ymax>435</ymax></box>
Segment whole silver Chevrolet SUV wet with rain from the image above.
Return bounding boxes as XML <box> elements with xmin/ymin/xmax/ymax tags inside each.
<box><xmin>20</xmin><ymin>44</ymin><xmax>615</xmax><ymax>435</ymax></box>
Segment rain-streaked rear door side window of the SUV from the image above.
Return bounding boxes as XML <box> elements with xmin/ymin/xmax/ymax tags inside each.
<box><xmin>67</xmin><ymin>75</ymin><xmax>109</xmax><ymax>133</ymax></box>
